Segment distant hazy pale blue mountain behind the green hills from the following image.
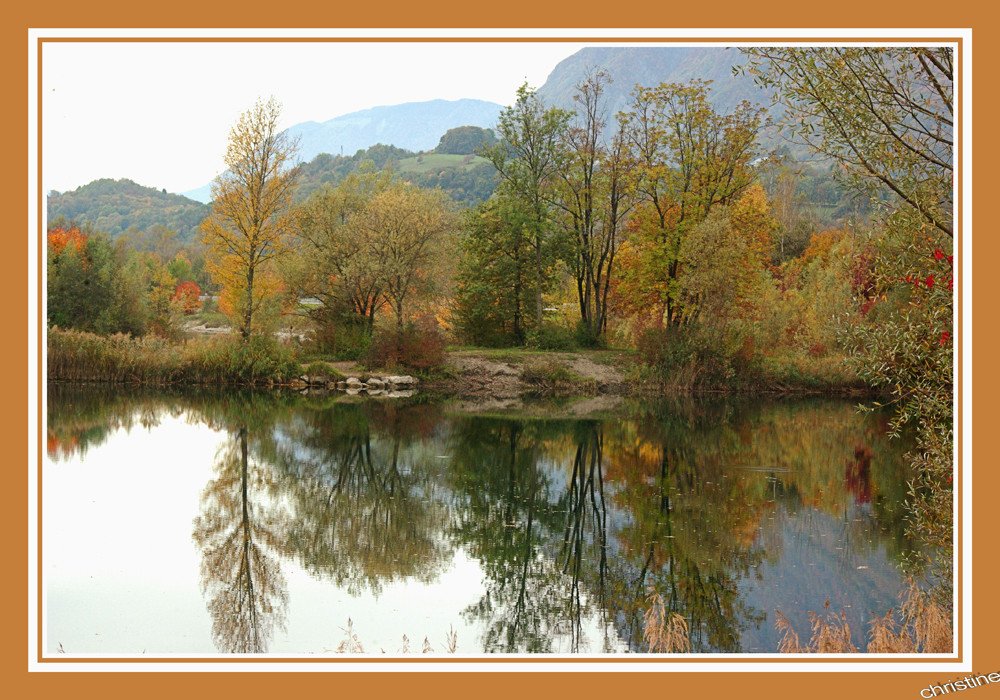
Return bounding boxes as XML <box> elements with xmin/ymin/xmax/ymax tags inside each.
<box><xmin>183</xmin><ymin>99</ymin><xmax>503</xmax><ymax>202</ymax></box>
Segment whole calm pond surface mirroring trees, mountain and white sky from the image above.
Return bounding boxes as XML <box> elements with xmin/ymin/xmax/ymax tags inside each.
<box><xmin>42</xmin><ymin>386</ymin><xmax>911</xmax><ymax>656</ymax></box>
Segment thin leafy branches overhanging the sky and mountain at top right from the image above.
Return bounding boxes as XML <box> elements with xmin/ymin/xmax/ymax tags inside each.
<box><xmin>742</xmin><ymin>46</ymin><xmax>954</xmax><ymax>236</ymax></box>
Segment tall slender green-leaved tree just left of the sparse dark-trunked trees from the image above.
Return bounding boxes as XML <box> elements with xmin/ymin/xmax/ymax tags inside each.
<box><xmin>483</xmin><ymin>84</ymin><xmax>569</xmax><ymax>326</ymax></box>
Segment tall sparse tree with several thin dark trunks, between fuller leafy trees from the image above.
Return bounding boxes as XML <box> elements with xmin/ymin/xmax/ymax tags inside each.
<box><xmin>555</xmin><ymin>71</ymin><xmax>633</xmax><ymax>340</ymax></box>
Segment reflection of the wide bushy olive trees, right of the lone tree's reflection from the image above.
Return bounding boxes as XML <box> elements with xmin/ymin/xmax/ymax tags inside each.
<box><xmin>275</xmin><ymin>404</ymin><xmax>451</xmax><ymax>595</ymax></box>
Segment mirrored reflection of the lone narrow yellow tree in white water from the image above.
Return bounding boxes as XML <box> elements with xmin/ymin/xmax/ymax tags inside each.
<box><xmin>193</xmin><ymin>426</ymin><xmax>288</xmax><ymax>653</ymax></box>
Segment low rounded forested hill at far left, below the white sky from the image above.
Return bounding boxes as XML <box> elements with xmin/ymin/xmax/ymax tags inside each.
<box><xmin>47</xmin><ymin>178</ymin><xmax>210</xmax><ymax>241</ymax></box>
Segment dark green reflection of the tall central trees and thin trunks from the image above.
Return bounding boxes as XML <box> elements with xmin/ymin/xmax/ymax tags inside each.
<box><xmin>452</xmin><ymin>419</ymin><xmax>613</xmax><ymax>652</ymax></box>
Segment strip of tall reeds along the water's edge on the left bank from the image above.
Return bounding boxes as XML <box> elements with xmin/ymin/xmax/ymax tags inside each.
<box><xmin>47</xmin><ymin>328</ymin><xmax>300</xmax><ymax>385</ymax></box>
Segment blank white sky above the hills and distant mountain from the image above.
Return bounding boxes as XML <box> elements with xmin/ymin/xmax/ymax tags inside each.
<box><xmin>41</xmin><ymin>41</ymin><xmax>584</xmax><ymax>192</ymax></box>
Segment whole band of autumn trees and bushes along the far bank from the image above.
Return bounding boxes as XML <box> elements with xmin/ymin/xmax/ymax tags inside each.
<box><xmin>47</xmin><ymin>71</ymin><xmax>892</xmax><ymax>391</ymax></box>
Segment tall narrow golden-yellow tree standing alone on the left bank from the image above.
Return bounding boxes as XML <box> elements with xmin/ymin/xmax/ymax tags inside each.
<box><xmin>201</xmin><ymin>97</ymin><xmax>297</xmax><ymax>342</ymax></box>
